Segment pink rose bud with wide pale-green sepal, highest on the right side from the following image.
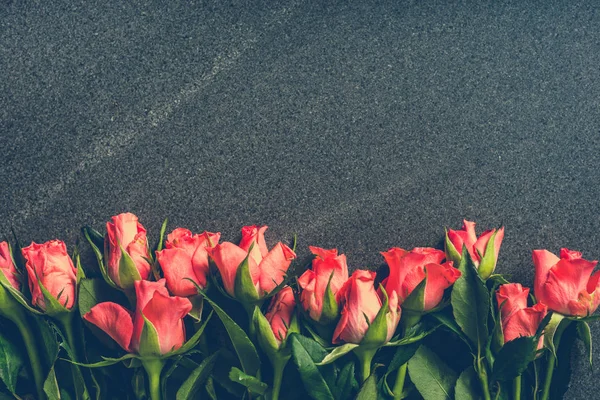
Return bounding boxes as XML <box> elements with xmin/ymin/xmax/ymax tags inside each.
<box><xmin>445</xmin><ymin>220</ymin><xmax>504</xmax><ymax>280</ymax></box>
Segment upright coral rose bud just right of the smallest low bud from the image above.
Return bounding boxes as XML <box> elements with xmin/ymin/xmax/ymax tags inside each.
<box><xmin>298</xmin><ymin>246</ymin><xmax>348</xmax><ymax>324</ymax></box>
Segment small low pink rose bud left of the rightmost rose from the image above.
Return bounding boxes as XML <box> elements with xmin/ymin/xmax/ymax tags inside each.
<box><xmin>496</xmin><ymin>283</ymin><xmax>548</xmax><ymax>348</ymax></box>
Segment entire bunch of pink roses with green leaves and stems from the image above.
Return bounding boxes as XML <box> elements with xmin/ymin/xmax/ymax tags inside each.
<box><xmin>0</xmin><ymin>217</ymin><xmax>600</xmax><ymax>400</ymax></box>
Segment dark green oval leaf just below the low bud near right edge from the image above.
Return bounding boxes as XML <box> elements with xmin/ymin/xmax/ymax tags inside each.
<box><xmin>492</xmin><ymin>336</ymin><xmax>538</xmax><ymax>381</ymax></box>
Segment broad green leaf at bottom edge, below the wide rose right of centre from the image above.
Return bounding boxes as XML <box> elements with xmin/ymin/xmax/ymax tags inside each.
<box><xmin>408</xmin><ymin>346</ymin><xmax>458</xmax><ymax>400</ymax></box>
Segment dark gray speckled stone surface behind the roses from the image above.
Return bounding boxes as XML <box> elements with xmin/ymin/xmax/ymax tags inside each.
<box><xmin>0</xmin><ymin>0</ymin><xmax>600</xmax><ymax>399</ymax></box>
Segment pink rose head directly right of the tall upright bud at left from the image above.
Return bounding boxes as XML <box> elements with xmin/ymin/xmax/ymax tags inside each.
<box><xmin>156</xmin><ymin>228</ymin><xmax>221</xmax><ymax>297</ymax></box>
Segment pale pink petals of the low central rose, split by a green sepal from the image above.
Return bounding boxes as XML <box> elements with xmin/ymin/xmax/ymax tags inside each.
<box><xmin>332</xmin><ymin>269</ymin><xmax>400</xmax><ymax>344</ymax></box>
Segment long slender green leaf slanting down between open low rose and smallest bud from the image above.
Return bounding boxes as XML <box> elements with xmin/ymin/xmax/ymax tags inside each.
<box><xmin>201</xmin><ymin>292</ymin><xmax>260</xmax><ymax>376</ymax></box>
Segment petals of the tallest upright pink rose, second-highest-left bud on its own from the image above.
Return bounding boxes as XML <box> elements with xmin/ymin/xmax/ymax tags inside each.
<box><xmin>104</xmin><ymin>213</ymin><xmax>151</xmax><ymax>287</ymax></box>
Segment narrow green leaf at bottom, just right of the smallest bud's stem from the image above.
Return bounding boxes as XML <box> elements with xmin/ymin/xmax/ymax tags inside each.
<box><xmin>288</xmin><ymin>333</ymin><xmax>334</xmax><ymax>400</ymax></box>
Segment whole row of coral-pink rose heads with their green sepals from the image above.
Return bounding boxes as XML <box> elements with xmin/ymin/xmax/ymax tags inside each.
<box><xmin>0</xmin><ymin>213</ymin><xmax>600</xmax><ymax>398</ymax></box>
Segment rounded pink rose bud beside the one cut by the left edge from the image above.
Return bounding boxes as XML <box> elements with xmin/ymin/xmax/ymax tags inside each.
<box><xmin>22</xmin><ymin>240</ymin><xmax>77</xmax><ymax>312</ymax></box>
